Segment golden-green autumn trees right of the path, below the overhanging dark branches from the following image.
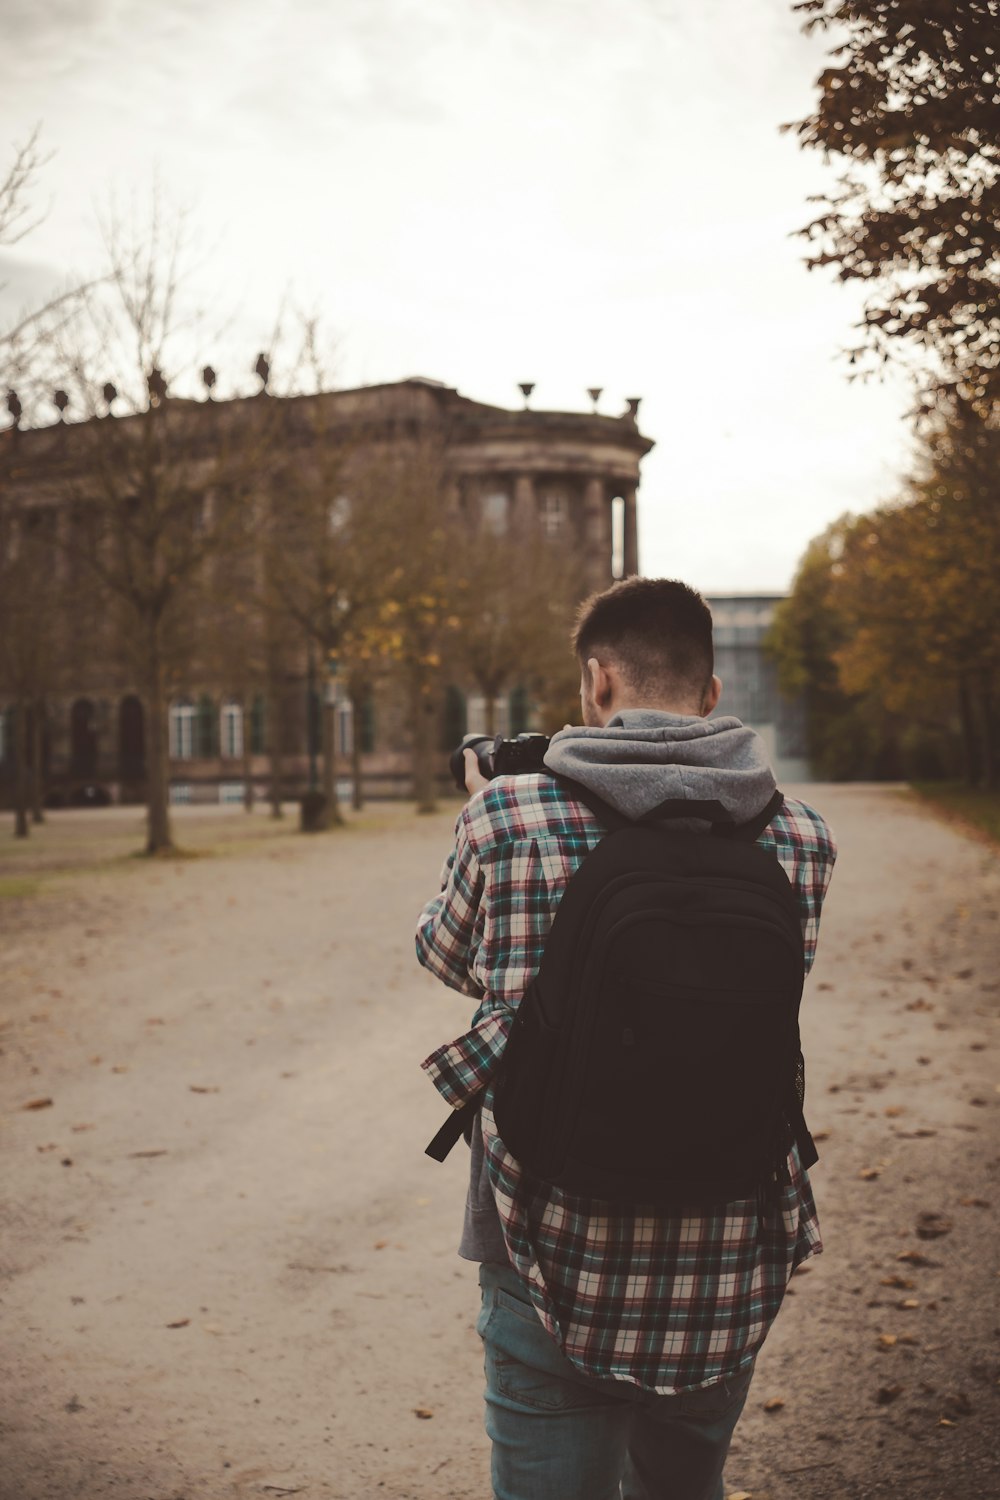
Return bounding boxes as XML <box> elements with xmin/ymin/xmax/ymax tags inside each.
<box><xmin>771</xmin><ymin>417</ymin><xmax>1000</xmax><ymax>786</ymax></box>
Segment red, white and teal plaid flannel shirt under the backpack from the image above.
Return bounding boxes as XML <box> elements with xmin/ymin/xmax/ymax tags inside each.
<box><xmin>417</xmin><ymin>776</ymin><xmax>837</xmax><ymax>1394</ymax></box>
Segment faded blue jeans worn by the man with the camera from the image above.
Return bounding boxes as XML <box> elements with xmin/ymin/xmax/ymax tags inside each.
<box><xmin>477</xmin><ymin>1263</ymin><xmax>753</xmax><ymax>1500</ymax></box>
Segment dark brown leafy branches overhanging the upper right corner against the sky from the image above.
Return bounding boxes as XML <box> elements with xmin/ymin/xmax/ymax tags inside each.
<box><xmin>786</xmin><ymin>0</ymin><xmax>1000</xmax><ymax>416</ymax></box>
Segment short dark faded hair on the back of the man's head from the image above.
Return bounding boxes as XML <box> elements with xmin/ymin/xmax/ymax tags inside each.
<box><xmin>573</xmin><ymin>578</ymin><xmax>715</xmax><ymax>702</ymax></box>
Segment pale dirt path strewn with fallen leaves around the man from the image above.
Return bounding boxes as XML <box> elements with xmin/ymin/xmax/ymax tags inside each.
<box><xmin>0</xmin><ymin>788</ymin><xmax>1000</xmax><ymax>1500</ymax></box>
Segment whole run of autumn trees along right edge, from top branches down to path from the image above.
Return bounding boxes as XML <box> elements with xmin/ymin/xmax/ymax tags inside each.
<box><xmin>771</xmin><ymin>0</ymin><xmax>1000</xmax><ymax>788</ymax></box>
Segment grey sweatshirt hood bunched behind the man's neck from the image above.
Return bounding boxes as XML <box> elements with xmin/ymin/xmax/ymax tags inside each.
<box><xmin>544</xmin><ymin>708</ymin><xmax>775</xmax><ymax>828</ymax></box>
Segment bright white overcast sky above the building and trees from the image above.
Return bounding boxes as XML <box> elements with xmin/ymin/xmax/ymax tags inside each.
<box><xmin>0</xmin><ymin>0</ymin><xmax>909</xmax><ymax>593</ymax></box>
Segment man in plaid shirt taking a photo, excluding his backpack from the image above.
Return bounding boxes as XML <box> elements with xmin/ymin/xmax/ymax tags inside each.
<box><xmin>417</xmin><ymin>578</ymin><xmax>835</xmax><ymax>1500</ymax></box>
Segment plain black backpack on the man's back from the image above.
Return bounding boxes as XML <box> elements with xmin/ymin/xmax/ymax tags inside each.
<box><xmin>427</xmin><ymin>777</ymin><xmax>817</xmax><ymax>1212</ymax></box>
